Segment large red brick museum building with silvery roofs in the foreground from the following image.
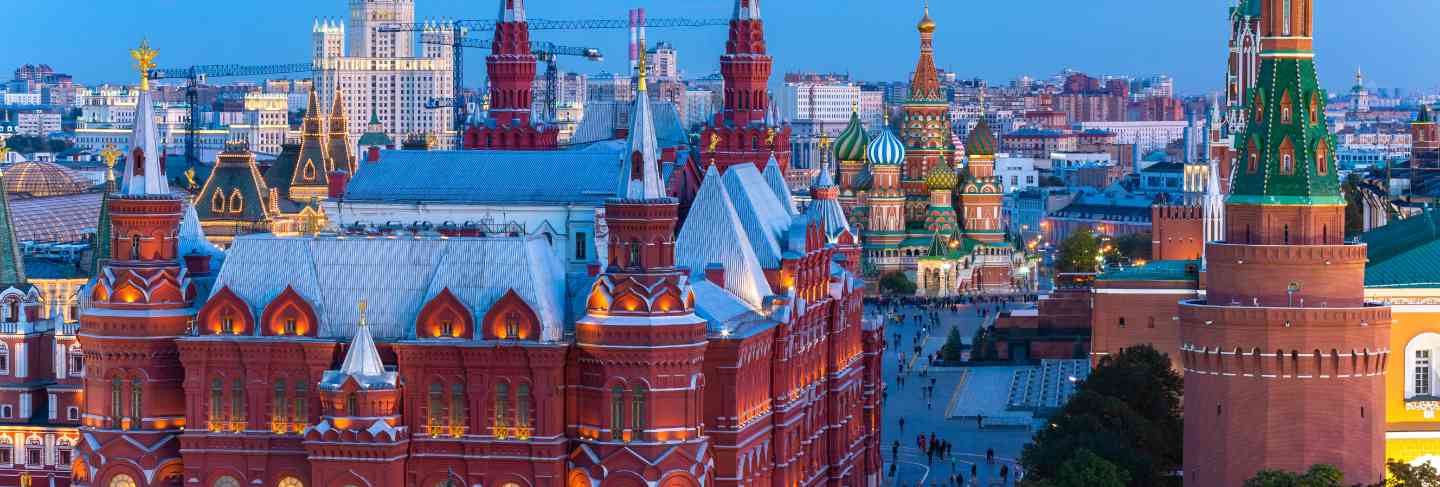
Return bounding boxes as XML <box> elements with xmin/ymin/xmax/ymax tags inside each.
<box><xmin>76</xmin><ymin>40</ymin><xmax>884</xmax><ymax>487</ymax></box>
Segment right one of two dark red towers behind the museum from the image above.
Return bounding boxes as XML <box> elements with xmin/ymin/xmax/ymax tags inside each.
<box><xmin>700</xmin><ymin>0</ymin><xmax>791</xmax><ymax>174</ymax></box>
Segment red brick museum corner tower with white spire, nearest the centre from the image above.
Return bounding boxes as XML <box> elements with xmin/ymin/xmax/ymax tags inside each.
<box><xmin>564</xmin><ymin>53</ymin><xmax>714</xmax><ymax>487</ymax></box>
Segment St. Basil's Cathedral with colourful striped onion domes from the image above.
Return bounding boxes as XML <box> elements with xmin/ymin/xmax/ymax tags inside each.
<box><xmin>834</xmin><ymin>7</ymin><xmax>1024</xmax><ymax>297</ymax></box>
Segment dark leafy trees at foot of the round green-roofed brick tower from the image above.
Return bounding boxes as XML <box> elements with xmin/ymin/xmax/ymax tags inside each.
<box><xmin>1021</xmin><ymin>346</ymin><xmax>1184</xmax><ymax>487</ymax></box>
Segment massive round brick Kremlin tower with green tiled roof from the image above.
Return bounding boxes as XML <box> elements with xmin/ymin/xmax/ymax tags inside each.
<box><xmin>1181</xmin><ymin>0</ymin><xmax>1391</xmax><ymax>486</ymax></box>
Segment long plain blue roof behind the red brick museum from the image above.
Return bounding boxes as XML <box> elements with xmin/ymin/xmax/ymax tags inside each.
<box><xmin>346</xmin><ymin>150</ymin><xmax>621</xmax><ymax>205</ymax></box>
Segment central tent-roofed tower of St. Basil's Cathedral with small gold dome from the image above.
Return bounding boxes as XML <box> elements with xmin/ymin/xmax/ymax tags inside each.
<box><xmin>900</xmin><ymin>4</ymin><xmax>955</xmax><ymax>223</ymax></box>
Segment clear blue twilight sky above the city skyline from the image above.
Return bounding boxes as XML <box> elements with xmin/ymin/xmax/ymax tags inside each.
<box><xmin>0</xmin><ymin>0</ymin><xmax>1440</xmax><ymax>94</ymax></box>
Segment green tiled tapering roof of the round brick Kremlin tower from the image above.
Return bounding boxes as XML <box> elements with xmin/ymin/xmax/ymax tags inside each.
<box><xmin>1227</xmin><ymin>46</ymin><xmax>1345</xmax><ymax>205</ymax></box>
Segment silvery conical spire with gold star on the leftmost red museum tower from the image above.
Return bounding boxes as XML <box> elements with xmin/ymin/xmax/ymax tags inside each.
<box><xmin>122</xmin><ymin>43</ymin><xmax>170</xmax><ymax>195</ymax></box>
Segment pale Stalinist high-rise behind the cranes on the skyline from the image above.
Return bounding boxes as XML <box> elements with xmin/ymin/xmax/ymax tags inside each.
<box><xmin>312</xmin><ymin>0</ymin><xmax>454</xmax><ymax>144</ymax></box>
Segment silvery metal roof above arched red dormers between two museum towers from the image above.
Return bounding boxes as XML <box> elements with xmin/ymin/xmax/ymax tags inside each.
<box><xmin>213</xmin><ymin>233</ymin><xmax>564</xmax><ymax>340</ymax></box>
